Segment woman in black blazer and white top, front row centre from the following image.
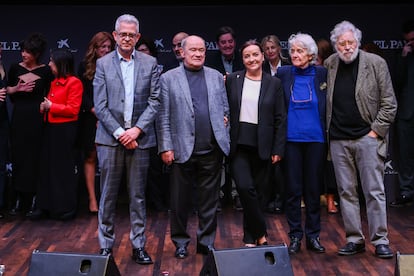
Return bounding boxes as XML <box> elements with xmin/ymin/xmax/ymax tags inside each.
<box><xmin>226</xmin><ymin>40</ymin><xmax>286</xmax><ymax>247</ymax></box>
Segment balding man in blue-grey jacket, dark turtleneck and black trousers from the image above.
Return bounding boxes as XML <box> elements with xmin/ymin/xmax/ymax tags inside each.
<box><xmin>157</xmin><ymin>35</ymin><xmax>230</xmax><ymax>259</ymax></box>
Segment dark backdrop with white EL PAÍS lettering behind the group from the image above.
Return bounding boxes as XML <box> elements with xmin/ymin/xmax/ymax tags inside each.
<box><xmin>0</xmin><ymin>3</ymin><xmax>414</xmax><ymax>199</ymax></box>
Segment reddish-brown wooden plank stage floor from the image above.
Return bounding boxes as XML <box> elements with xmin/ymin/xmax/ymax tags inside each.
<box><xmin>0</xmin><ymin>197</ymin><xmax>414</xmax><ymax>276</ymax></box>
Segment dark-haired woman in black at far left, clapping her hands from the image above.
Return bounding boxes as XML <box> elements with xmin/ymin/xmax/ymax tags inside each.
<box><xmin>7</xmin><ymin>33</ymin><xmax>53</xmax><ymax>216</ymax></box>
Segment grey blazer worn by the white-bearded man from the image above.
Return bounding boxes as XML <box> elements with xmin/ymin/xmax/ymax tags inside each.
<box><xmin>324</xmin><ymin>50</ymin><xmax>397</xmax><ymax>158</ymax></box>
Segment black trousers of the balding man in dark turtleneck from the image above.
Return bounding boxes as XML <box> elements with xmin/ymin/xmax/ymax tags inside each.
<box><xmin>170</xmin><ymin>148</ymin><xmax>223</xmax><ymax>247</ymax></box>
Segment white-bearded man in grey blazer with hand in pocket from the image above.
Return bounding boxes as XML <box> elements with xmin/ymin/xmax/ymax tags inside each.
<box><xmin>324</xmin><ymin>21</ymin><xmax>397</xmax><ymax>258</ymax></box>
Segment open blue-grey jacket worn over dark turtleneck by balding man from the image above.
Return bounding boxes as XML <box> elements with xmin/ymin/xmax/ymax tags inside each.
<box><xmin>157</xmin><ymin>65</ymin><xmax>230</xmax><ymax>163</ymax></box>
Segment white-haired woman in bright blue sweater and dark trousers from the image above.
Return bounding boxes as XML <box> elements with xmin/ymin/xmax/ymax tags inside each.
<box><xmin>276</xmin><ymin>33</ymin><xmax>327</xmax><ymax>254</ymax></box>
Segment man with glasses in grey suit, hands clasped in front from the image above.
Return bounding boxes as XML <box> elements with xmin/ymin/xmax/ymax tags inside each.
<box><xmin>93</xmin><ymin>14</ymin><xmax>160</xmax><ymax>264</ymax></box>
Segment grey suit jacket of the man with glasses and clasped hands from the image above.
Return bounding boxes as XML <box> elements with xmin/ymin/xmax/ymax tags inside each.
<box><xmin>93</xmin><ymin>50</ymin><xmax>160</xmax><ymax>148</ymax></box>
